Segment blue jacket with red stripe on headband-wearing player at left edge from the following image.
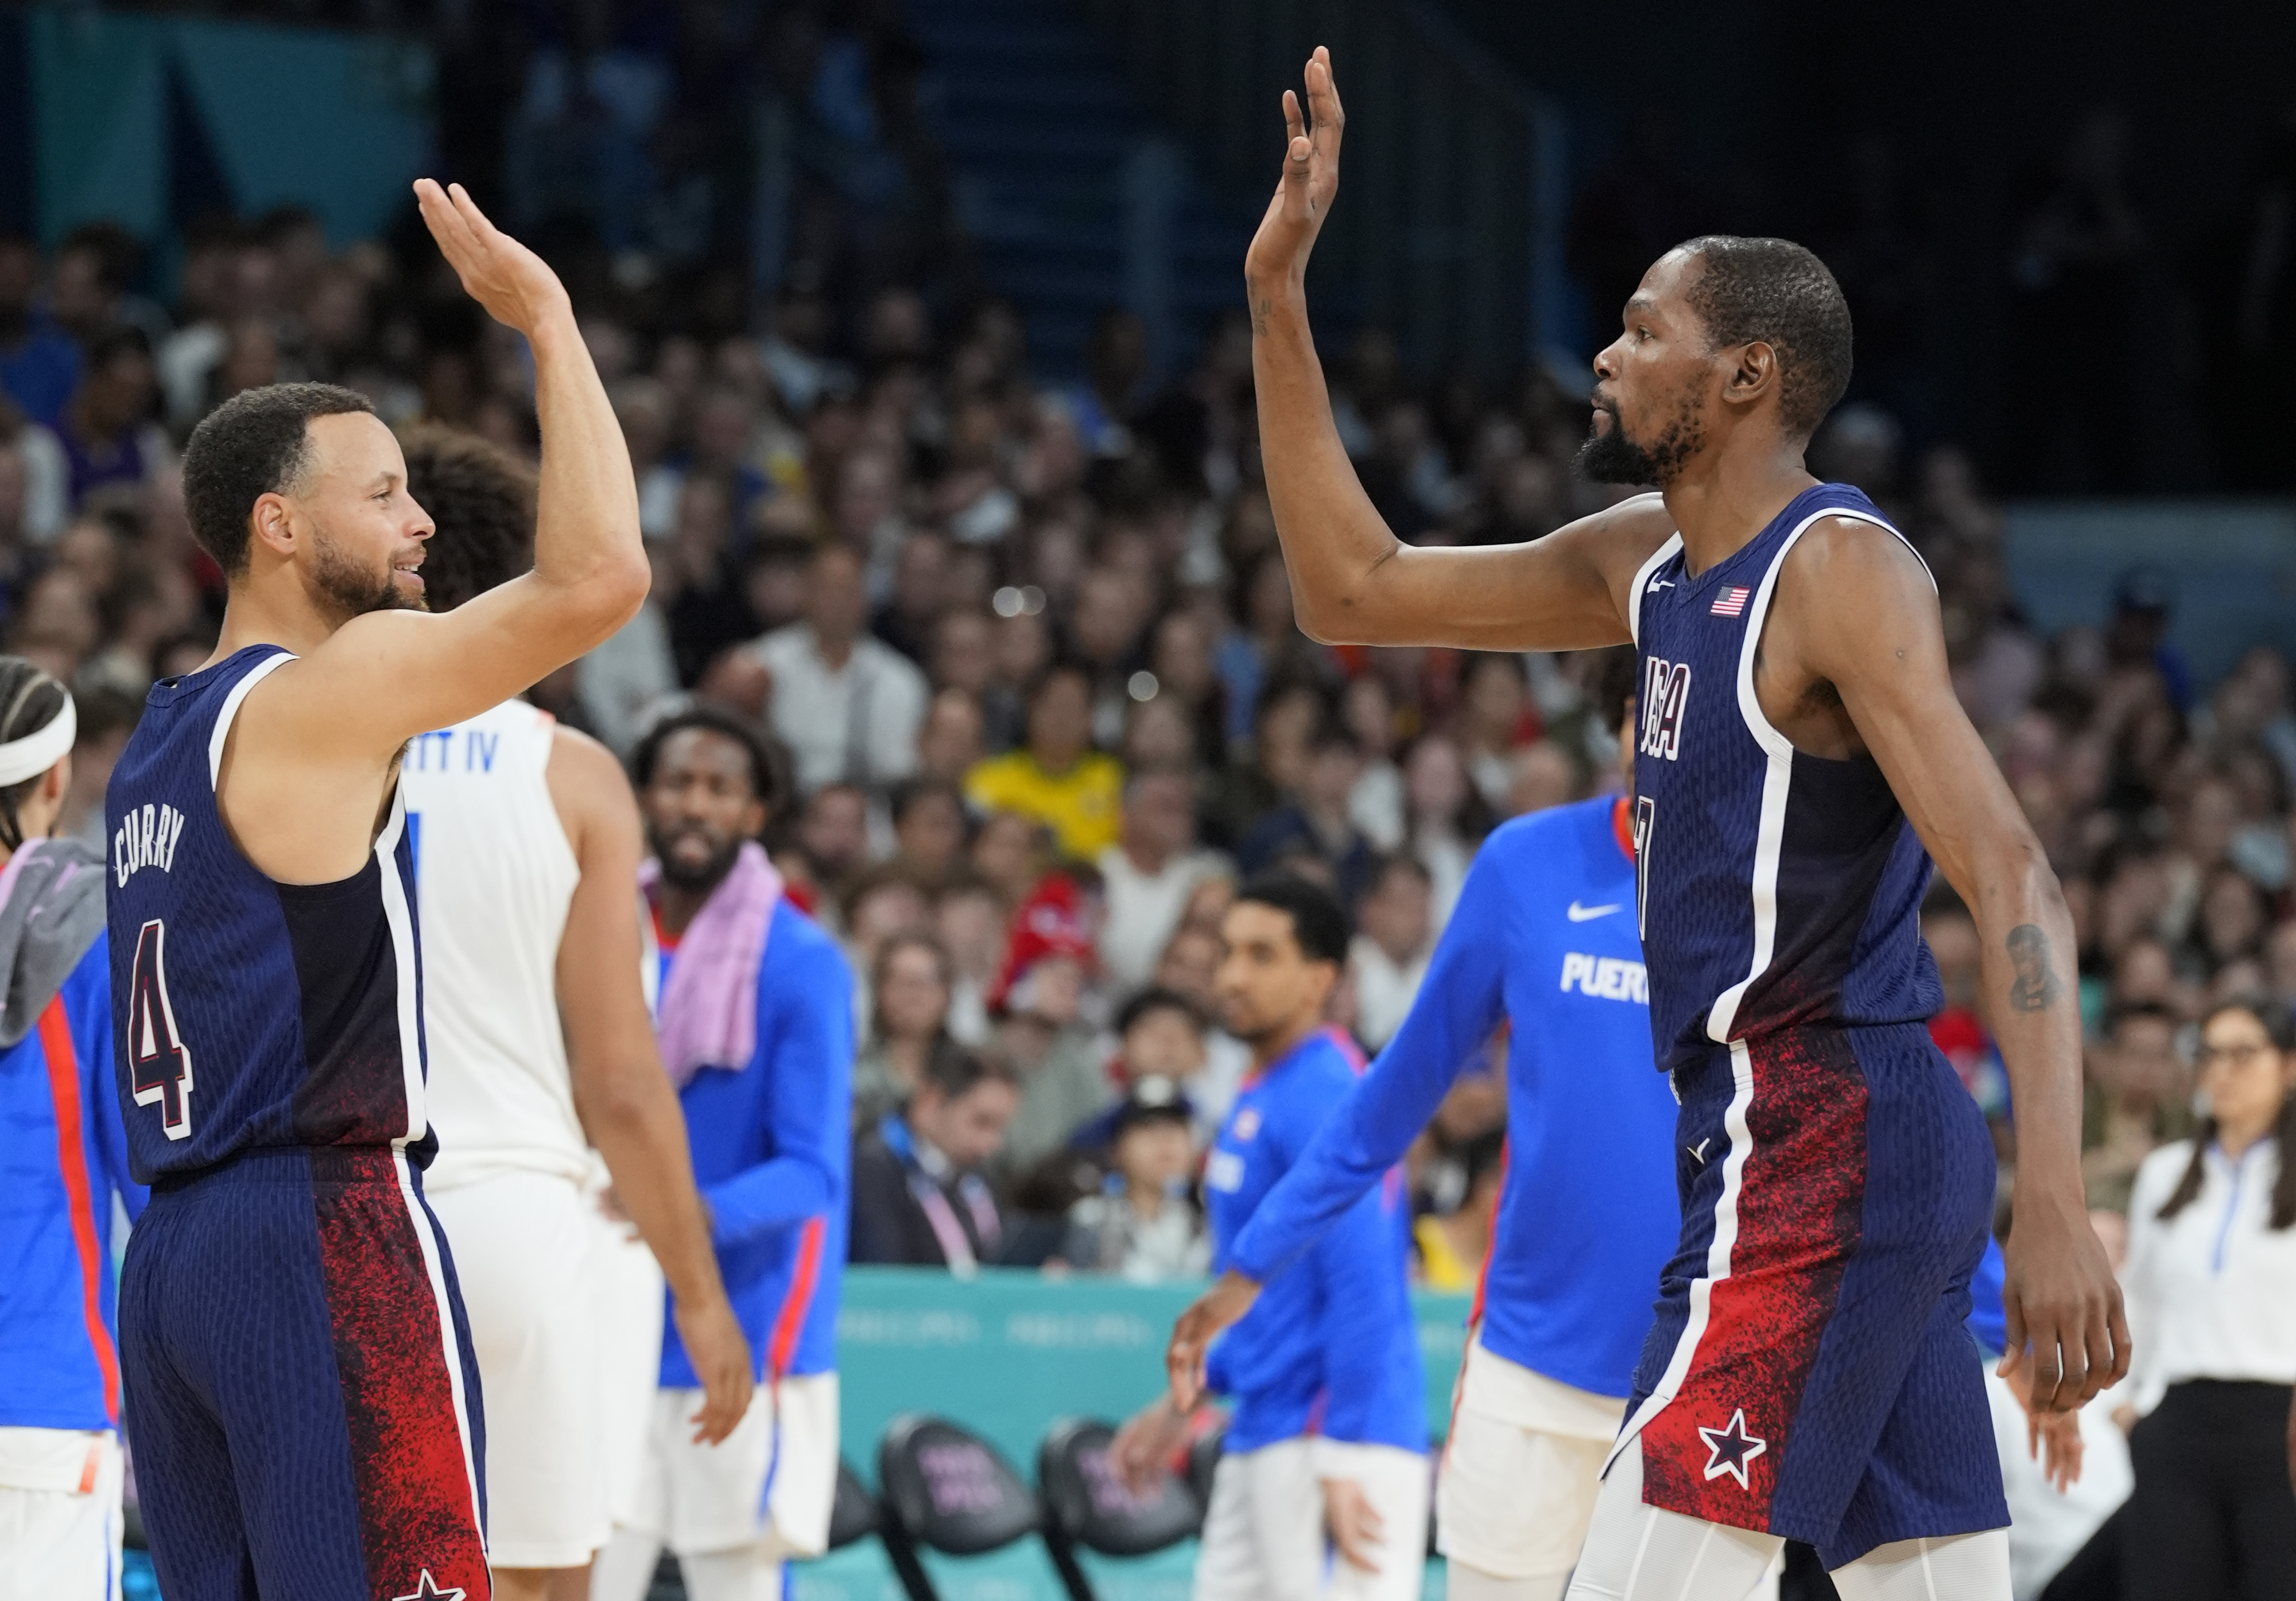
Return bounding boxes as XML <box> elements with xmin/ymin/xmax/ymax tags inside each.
<box><xmin>0</xmin><ymin>931</ymin><xmax>147</xmax><ymax>1429</ymax></box>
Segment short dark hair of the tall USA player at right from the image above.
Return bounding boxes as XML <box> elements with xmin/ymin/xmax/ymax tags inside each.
<box><xmin>1678</xmin><ymin>234</ymin><xmax>1851</xmax><ymax>438</ymax></box>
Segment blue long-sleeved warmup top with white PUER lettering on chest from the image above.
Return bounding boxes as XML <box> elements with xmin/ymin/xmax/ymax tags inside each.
<box><xmin>1228</xmin><ymin>796</ymin><xmax>1681</xmax><ymax>1397</ymax></box>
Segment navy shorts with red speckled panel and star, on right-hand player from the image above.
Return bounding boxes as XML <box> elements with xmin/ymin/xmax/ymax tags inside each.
<box><xmin>1619</xmin><ymin>1025</ymin><xmax>2009</xmax><ymax>1569</ymax></box>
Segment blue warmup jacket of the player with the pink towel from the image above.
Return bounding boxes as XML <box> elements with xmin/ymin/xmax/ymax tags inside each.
<box><xmin>661</xmin><ymin>899</ymin><xmax>854</xmax><ymax>1388</ymax></box>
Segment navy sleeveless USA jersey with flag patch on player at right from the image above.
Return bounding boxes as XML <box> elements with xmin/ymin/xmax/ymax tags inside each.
<box><xmin>1628</xmin><ymin>484</ymin><xmax>1942</xmax><ymax>1071</ymax></box>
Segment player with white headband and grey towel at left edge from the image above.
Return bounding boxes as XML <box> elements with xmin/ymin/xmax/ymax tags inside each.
<box><xmin>0</xmin><ymin>656</ymin><xmax>145</xmax><ymax>1601</ymax></box>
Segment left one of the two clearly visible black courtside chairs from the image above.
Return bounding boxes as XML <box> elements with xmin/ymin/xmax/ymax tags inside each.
<box><xmin>877</xmin><ymin>1413</ymin><xmax>1045</xmax><ymax>1601</ymax></box>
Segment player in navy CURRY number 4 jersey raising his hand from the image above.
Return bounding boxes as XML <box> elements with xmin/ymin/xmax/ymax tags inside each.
<box><xmin>106</xmin><ymin>179</ymin><xmax>647</xmax><ymax>1601</ymax></box>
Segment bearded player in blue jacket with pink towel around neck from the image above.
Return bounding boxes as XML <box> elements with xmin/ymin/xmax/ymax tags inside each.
<box><xmin>590</xmin><ymin>706</ymin><xmax>854</xmax><ymax>1601</ymax></box>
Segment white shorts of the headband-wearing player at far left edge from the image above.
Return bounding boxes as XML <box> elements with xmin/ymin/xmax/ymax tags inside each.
<box><xmin>0</xmin><ymin>1429</ymin><xmax>122</xmax><ymax>1601</ymax></box>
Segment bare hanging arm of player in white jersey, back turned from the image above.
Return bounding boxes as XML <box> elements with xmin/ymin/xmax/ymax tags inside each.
<box><xmin>546</xmin><ymin>729</ymin><xmax>753</xmax><ymax>1443</ymax></box>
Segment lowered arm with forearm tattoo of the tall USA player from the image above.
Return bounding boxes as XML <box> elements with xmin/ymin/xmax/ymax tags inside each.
<box><xmin>1791</xmin><ymin>523</ymin><xmax>2128</xmax><ymax>1413</ymax></box>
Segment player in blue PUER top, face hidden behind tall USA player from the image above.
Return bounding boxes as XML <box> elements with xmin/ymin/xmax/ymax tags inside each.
<box><xmin>1171</xmin><ymin>651</ymin><xmax>1681</xmax><ymax>1601</ymax></box>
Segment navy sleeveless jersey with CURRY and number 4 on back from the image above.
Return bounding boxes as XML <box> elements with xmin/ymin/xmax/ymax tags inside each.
<box><xmin>103</xmin><ymin>644</ymin><xmax>434</xmax><ymax>1184</ymax></box>
